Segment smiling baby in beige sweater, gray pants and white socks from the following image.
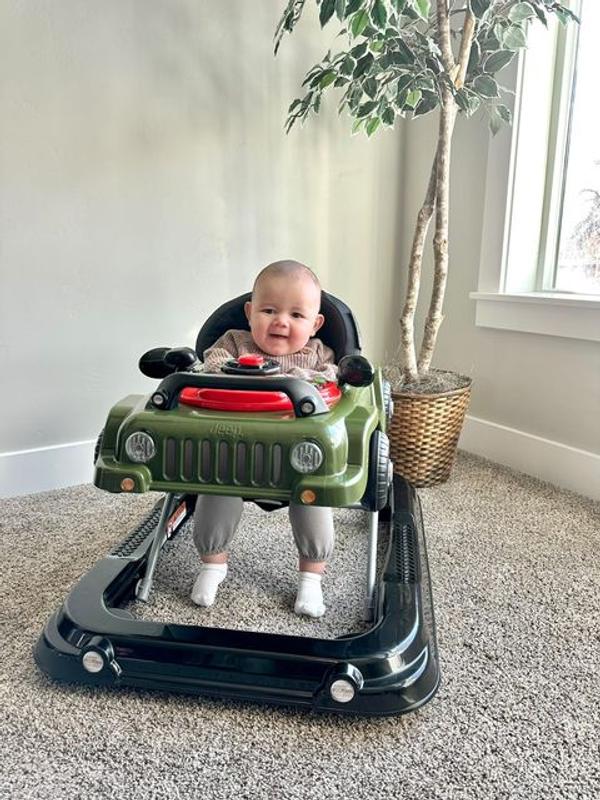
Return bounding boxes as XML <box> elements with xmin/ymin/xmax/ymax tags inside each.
<box><xmin>191</xmin><ymin>261</ymin><xmax>337</xmax><ymax>617</ymax></box>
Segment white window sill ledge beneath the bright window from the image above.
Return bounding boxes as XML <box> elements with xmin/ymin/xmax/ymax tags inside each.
<box><xmin>469</xmin><ymin>292</ymin><xmax>600</xmax><ymax>342</ymax></box>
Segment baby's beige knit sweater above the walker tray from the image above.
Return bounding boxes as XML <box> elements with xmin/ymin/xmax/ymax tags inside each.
<box><xmin>203</xmin><ymin>330</ymin><xmax>337</xmax><ymax>381</ymax></box>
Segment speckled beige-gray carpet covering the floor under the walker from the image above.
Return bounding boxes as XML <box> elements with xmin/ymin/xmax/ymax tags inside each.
<box><xmin>0</xmin><ymin>455</ymin><xmax>600</xmax><ymax>800</ymax></box>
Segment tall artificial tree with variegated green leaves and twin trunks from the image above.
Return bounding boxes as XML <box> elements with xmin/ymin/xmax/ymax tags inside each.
<box><xmin>275</xmin><ymin>0</ymin><xmax>576</xmax><ymax>391</ymax></box>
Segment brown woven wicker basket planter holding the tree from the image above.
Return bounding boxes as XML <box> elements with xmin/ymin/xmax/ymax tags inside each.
<box><xmin>389</xmin><ymin>378</ymin><xmax>471</xmax><ymax>486</ymax></box>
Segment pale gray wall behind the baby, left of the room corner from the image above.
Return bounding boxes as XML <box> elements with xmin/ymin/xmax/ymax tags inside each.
<box><xmin>0</xmin><ymin>0</ymin><xmax>401</xmax><ymax>456</ymax></box>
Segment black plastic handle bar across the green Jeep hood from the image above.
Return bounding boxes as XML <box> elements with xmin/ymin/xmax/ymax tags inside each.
<box><xmin>146</xmin><ymin>372</ymin><xmax>329</xmax><ymax>417</ymax></box>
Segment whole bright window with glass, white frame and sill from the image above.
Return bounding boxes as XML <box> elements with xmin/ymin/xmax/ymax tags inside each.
<box><xmin>471</xmin><ymin>0</ymin><xmax>600</xmax><ymax>341</ymax></box>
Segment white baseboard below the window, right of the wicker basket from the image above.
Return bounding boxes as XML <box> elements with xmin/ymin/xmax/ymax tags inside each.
<box><xmin>459</xmin><ymin>416</ymin><xmax>600</xmax><ymax>500</ymax></box>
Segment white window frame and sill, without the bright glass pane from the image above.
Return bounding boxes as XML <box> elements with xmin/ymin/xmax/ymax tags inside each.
<box><xmin>470</xmin><ymin>0</ymin><xmax>600</xmax><ymax>341</ymax></box>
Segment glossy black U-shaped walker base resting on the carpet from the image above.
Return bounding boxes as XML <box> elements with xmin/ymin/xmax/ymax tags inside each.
<box><xmin>35</xmin><ymin>476</ymin><xmax>439</xmax><ymax>716</ymax></box>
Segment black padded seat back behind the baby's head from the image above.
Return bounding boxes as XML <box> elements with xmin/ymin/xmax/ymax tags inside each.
<box><xmin>196</xmin><ymin>292</ymin><xmax>361</xmax><ymax>363</ymax></box>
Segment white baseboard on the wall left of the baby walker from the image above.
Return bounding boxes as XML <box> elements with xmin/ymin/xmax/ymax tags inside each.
<box><xmin>0</xmin><ymin>439</ymin><xmax>96</xmax><ymax>497</ymax></box>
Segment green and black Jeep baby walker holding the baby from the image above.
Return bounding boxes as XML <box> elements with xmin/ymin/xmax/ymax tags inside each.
<box><xmin>35</xmin><ymin>292</ymin><xmax>439</xmax><ymax>715</ymax></box>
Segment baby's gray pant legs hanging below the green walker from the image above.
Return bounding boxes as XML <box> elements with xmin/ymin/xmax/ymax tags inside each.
<box><xmin>194</xmin><ymin>494</ymin><xmax>334</xmax><ymax>561</ymax></box>
